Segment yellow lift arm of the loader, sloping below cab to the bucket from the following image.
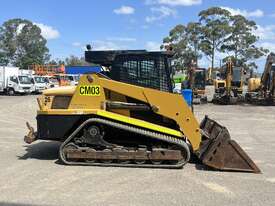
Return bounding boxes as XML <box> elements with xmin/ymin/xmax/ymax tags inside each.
<box><xmin>99</xmin><ymin>75</ymin><xmax>201</xmax><ymax>151</ymax></box>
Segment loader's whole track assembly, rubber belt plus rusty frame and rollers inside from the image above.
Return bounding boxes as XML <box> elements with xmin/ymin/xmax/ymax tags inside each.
<box><xmin>59</xmin><ymin>118</ymin><xmax>190</xmax><ymax>168</ymax></box>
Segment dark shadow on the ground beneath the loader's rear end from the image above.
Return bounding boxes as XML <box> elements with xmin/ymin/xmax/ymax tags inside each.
<box><xmin>17</xmin><ymin>141</ymin><xmax>61</xmax><ymax>160</ymax></box>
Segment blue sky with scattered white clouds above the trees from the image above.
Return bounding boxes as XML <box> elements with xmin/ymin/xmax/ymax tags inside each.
<box><xmin>0</xmin><ymin>0</ymin><xmax>275</xmax><ymax>71</ymax></box>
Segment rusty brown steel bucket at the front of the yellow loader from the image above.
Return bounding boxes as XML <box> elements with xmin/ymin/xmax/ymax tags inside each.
<box><xmin>198</xmin><ymin>116</ymin><xmax>261</xmax><ymax>173</ymax></box>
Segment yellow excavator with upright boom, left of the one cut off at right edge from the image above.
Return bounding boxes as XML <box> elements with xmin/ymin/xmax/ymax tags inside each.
<box><xmin>212</xmin><ymin>59</ymin><xmax>244</xmax><ymax>105</ymax></box>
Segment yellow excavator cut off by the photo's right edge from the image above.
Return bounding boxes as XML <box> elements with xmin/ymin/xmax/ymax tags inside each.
<box><xmin>245</xmin><ymin>53</ymin><xmax>275</xmax><ymax>105</ymax></box>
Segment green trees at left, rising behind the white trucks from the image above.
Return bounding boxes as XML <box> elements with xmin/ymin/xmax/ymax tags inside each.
<box><xmin>0</xmin><ymin>18</ymin><xmax>88</xmax><ymax>69</ymax></box>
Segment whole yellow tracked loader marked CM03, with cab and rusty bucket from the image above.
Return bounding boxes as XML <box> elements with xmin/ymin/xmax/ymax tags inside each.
<box><xmin>25</xmin><ymin>50</ymin><xmax>260</xmax><ymax>173</ymax></box>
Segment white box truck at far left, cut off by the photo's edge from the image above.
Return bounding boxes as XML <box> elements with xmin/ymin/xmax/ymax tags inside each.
<box><xmin>0</xmin><ymin>66</ymin><xmax>32</xmax><ymax>95</ymax></box>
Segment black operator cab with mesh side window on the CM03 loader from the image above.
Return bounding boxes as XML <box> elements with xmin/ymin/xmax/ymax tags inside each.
<box><xmin>85</xmin><ymin>50</ymin><xmax>173</xmax><ymax>92</ymax></box>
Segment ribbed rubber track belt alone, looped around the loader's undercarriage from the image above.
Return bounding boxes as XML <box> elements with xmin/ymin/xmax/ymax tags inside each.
<box><xmin>59</xmin><ymin>118</ymin><xmax>190</xmax><ymax>168</ymax></box>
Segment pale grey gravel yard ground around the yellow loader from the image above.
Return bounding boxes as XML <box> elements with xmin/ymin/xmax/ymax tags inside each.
<box><xmin>0</xmin><ymin>92</ymin><xmax>275</xmax><ymax>206</ymax></box>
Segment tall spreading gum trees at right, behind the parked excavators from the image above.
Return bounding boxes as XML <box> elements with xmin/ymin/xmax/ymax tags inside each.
<box><xmin>161</xmin><ymin>7</ymin><xmax>269</xmax><ymax>70</ymax></box>
